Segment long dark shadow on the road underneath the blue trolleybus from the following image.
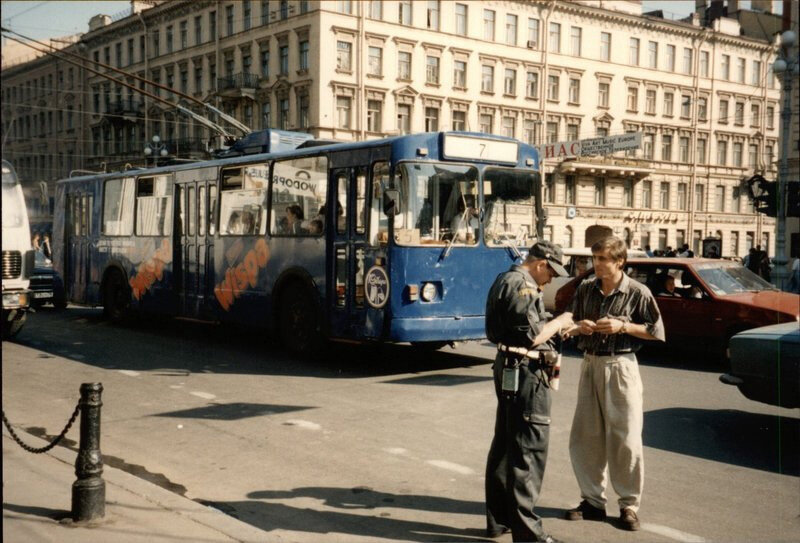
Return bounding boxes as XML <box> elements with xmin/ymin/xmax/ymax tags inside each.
<box><xmin>14</xmin><ymin>307</ymin><xmax>489</xmax><ymax>378</ymax></box>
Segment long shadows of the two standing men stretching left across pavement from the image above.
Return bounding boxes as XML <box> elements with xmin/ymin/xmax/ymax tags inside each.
<box><xmin>197</xmin><ymin>487</ymin><xmax>492</xmax><ymax>542</ymax></box>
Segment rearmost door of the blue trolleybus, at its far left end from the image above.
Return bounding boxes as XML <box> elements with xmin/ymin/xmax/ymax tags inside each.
<box><xmin>64</xmin><ymin>192</ymin><xmax>93</xmax><ymax>303</ymax></box>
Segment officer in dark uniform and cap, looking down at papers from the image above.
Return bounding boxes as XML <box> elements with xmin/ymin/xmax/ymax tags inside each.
<box><xmin>486</xmin><ymin>241</ymin><xmax>572</xmax><ymax>542</ymax></box>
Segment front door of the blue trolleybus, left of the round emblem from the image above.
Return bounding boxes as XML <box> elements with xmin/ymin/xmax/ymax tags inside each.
<box><xmin>329</xmin><ymin>166</ymin><xmax>368</xmax><ymax>337</ymax></box>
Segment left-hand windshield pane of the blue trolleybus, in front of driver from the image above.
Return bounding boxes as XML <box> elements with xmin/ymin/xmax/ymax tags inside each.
<box><xmin>394</xmin><ymin>162</ymin><xmax>479</xmax><ymax>245</ymax></box>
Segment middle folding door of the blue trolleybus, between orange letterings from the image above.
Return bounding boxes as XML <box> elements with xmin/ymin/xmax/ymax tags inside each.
<box><xmin>173</xmin><ymin>172</ymin><xmax>216</xmax><ymax>317</ymax></box>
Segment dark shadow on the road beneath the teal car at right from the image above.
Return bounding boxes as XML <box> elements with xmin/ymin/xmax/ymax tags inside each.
<box><xmin>642</xmin><ymin>407</ymin><xmax>800</xmax><ymax>476</ymax></box>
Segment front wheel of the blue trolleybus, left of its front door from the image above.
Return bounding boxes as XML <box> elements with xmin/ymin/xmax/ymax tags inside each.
<box><xmin>279</xmin><ymin>283</ymin><xmax>322</xmax><ymax>356</ymax></box>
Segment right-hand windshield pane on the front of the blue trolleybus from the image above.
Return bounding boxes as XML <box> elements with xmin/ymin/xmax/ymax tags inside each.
<box><xmin>483</xmin><ymin>168</ymin><xmax>537</xmax><ymax>247</ymax></box>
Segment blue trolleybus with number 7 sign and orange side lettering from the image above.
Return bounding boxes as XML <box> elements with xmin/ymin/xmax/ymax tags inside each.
<box><xmin>53</xmin><ymin>132</ymin><xmax>543</xmax><ymax>353</ymax></box>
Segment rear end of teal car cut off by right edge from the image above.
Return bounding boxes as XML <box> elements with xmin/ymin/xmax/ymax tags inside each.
<box><xmin>719</xmin><ymin>322</ymin><xmax>800</xmax><ymax>408</ymax></box>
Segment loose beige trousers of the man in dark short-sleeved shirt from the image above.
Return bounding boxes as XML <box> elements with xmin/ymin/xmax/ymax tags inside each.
<box><xmin>569</xmin><ymin>353</ymin><xmax>644</xmax><ymax>511</ymax></box>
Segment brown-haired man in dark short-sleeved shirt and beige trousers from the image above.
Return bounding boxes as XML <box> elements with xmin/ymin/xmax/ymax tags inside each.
<box><xmin>566</xmin><ymin>237</ymin><xmax>664</xmax><ymax>530</ymax></box>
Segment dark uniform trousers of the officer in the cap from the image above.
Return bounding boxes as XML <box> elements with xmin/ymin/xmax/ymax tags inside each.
<box><xmin>486</xmin><ymin>353</ymin><xmax>551</xmax><ymax>541</ymax></box>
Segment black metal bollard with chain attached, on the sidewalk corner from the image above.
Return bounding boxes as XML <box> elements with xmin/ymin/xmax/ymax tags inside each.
<box><xmin>72</xmin><ymin>383</ymin><xmax>106</xmax><ymax>522</ymax></box>
